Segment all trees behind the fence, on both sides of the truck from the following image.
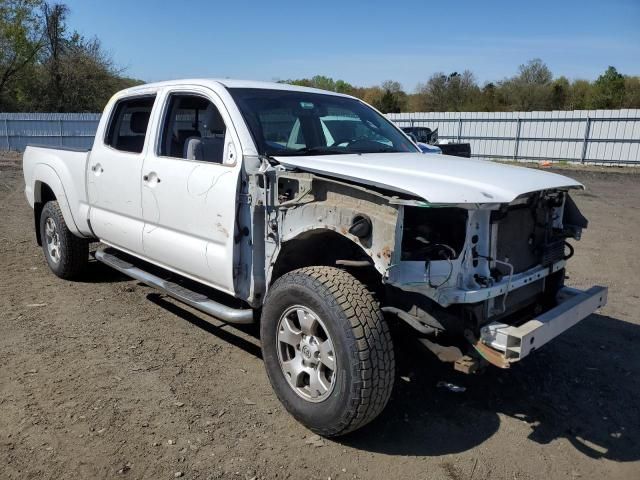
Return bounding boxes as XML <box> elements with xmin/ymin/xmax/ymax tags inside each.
<box><xmin>0</xmin><ymin>0</ymin><xmax>640</xmax><ymax>113</ymax></box>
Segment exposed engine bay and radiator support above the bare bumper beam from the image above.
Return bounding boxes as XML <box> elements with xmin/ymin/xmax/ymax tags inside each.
<box><xmin>387</xmin><ymin>190</ymin><xmax>587</xmax><ymax>325</ymax></box>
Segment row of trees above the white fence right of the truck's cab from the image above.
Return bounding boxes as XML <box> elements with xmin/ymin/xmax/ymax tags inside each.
<box><xmin>282</xmin><ymin>58</ymin><xmax>640</xmax><ymax>113</ymax></box>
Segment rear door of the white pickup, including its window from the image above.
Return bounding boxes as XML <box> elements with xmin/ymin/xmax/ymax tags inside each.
<box><xmin>87</xmin><ymin>94</ymin><xmax>155</xmax><ymax>254</ymax></box>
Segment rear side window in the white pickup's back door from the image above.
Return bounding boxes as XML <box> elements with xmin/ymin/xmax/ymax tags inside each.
<box><xmin>105</xmin><ymin>95</ymin><xmax>156</xmax><ymax>153</ymax></box>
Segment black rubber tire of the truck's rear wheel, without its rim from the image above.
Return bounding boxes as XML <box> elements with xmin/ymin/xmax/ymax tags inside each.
<box><xmin>40</xmin><ymin>201</ymin><xmax>89</xmax><ymax>280</ymax></box>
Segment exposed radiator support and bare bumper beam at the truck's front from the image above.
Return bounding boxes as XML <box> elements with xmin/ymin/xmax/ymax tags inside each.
<box><xmin>385</xmin><ymin>189</ymin><xmax>607</xmax><ymax>368</ymax></box>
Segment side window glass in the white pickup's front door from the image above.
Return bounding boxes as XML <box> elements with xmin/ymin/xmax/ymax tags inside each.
<box><xmin>159</xmin><ymin>94</ymin><xmax>227</xmax><ymax>163</ymax></box>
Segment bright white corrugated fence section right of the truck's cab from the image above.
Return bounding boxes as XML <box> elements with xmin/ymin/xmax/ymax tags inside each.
<box><xmin>387</xmin><ymin>110</ymin><xmax>640</xmax><ymax>165</ymax></box>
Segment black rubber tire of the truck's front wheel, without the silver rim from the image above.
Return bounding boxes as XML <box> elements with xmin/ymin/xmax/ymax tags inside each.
<box><xmin>260</xmin><ymin>266</ymin><xmax>395</xmax><ymax>437</ymax></box>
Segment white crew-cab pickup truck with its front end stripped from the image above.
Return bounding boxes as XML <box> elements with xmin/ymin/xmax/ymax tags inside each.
<box><xmin>24</xmin><ymin>80</ymin><xmax>607</xmax><ymax>436</ymax></box>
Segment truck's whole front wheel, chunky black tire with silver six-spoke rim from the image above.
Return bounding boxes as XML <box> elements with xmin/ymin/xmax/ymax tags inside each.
<box><xmin>260</xmin><ymin>266</ymin><xmax>395</xmax><ymax>436</ymax></box>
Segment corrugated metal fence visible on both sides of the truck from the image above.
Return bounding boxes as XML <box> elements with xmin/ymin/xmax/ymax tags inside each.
<box><xmin>0</xmin><ymin>110</ymin><xmax>640</xmax><ymax>165</ymax></box>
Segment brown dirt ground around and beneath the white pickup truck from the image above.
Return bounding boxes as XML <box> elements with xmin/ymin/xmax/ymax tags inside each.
<box><xmin>0</xmin><ymin>156</ymin><xmax>640</xmax><ymax>480</ymax></box>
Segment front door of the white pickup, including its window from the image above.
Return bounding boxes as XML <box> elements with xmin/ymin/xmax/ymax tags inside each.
<box><xmin>142</xmin><ymin>89</ymin><xmax>240</xmax><ymax>294</ymax></box>
